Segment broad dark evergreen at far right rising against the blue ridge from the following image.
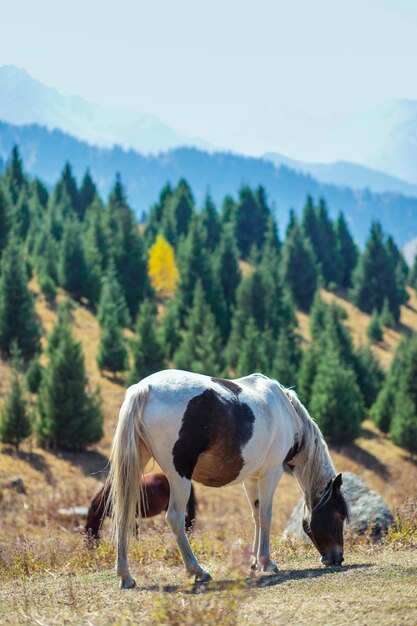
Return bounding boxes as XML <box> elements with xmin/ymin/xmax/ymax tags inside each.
<box><xmin>352</xmin><ymin>223</ymin><xmax>403</xmax><ymax>321</ymax></box>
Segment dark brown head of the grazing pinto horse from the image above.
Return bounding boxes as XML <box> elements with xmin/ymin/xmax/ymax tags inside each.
<box><xmin>303</xmin><ymin>474</ymin><xmax>349</xmax><ymax>566</ymax></box>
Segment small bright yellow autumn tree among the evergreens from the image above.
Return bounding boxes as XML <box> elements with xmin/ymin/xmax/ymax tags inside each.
<box><xmin>148</xmin><ymin>235</ymin><xmax>180</xmax><ymax>298</ymax></box>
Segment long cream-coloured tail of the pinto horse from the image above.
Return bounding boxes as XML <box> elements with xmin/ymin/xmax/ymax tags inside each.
<box><xmin>107</xmin><ymin>384</ymin><xmax>149</xmax><ymax>548</ymax></box>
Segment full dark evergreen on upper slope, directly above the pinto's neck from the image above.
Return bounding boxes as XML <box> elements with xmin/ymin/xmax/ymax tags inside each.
<box><xmin>282</xmin><ymin>218</ymin><xmax>317</xmax><ymax>311</ymax></box>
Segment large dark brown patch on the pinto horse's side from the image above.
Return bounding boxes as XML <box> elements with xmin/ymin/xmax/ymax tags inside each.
<box><xmin>172</xmin><ymin>388</ymin><xmax>255</xmax><ymax>487</ymax></box>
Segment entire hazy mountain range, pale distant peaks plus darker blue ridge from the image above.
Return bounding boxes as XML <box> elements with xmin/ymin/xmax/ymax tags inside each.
<box><xmin>0</xmin><ymin>66</ymin><xmax>417</xmax><ymax>245</ymax></box>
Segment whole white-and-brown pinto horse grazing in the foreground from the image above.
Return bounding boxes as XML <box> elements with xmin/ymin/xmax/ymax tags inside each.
<box><xmin>109</xmin><ymin>370</ymin><xmax>348</xmax><ymax>588</ymax></box>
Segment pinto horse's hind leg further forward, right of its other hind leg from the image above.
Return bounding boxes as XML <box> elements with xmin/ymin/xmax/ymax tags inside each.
<box><xmin>166</xmin><ymin>473</ymin><xmax>211</xmax><ymax>582</ymax></box>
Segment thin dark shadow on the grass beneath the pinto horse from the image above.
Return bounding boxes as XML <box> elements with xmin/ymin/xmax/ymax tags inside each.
<box><xmin>137</xmin><ymin>563</ymin><xmax>374</xmax><ymax>594</ymax></box>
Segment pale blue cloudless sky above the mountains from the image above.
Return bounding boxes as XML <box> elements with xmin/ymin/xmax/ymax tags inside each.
<box><xmin>0</xmin><ymin>0</ymin><xmax>417</xmax><ymax>153</ymax></box>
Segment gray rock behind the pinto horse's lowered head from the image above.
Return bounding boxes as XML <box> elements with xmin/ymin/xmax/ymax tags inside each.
<box><xmin>284</xmin><ymin>472</ymin><xmax>394</xmax><ymax>541</ymax></box>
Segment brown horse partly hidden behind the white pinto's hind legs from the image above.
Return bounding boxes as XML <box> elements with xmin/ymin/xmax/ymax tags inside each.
<box><xmin>85</xmin><ymin>473</ymin><xmax>196</xmax><ymax>542</ymax></box>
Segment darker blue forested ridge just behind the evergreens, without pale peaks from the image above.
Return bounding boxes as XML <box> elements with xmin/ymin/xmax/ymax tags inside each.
<box><xmin>0</xmin><ymin>122</ymin><xmax>417</xmax><ymax>245</ymax></box>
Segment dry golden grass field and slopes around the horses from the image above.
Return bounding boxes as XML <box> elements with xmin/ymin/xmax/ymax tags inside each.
<box><xmin>0</xmin><ymin>283</ymin><xmax>417</xmax><ymax>626</ymax></box>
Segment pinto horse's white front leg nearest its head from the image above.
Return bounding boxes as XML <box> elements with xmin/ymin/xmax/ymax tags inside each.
<box><xmin>258</xmin><ymin>465</ymin><xmax>283</xmax><ymax>572</ymax></box>
